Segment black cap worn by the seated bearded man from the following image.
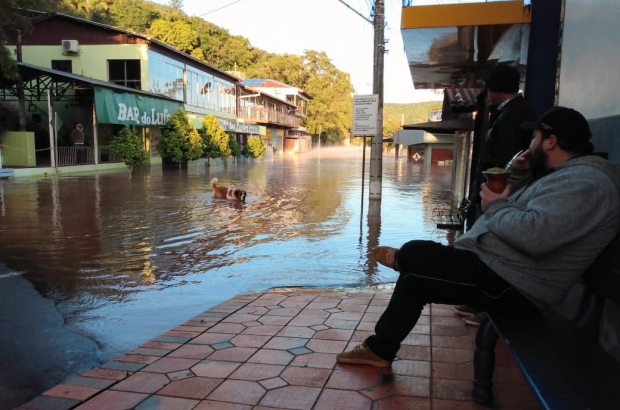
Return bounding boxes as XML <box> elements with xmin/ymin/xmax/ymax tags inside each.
<box><xmin>521</xmin><ymin>107</ymin><xmax>592</xmax><ymax>145</ymax></box>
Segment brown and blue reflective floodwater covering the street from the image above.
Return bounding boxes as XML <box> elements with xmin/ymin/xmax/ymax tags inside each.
<box><xmin>0</xmin><ymin>148</ymin><xmax>454</xmax><ymax>360</ymax></box>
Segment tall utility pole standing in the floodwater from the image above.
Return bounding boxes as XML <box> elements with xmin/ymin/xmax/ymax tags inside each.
<box><xmin>368</xmin><ymin>0</ymin><xmax>385</xmax><ymax>201</ymax></box>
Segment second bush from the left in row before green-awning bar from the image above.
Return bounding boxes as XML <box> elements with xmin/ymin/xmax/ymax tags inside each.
<box><xmin>157</xmin><ymin>108</ymin><xmax>202</xmax><ymax>164</ymax></box>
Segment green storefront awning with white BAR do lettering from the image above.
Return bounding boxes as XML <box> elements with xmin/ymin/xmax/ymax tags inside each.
<box><xmin>95</xmin><ymin>87</ymin><xmax>183</xmax><ymax>127</ymax></box>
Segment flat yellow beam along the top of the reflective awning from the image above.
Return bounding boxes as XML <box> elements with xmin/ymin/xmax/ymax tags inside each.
<box><xmin>401</xmin><ymin>0</ymin><xmax>531</xmax><ymax>29</ymax></box>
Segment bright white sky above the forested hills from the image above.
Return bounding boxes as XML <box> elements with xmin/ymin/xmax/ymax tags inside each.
<box><xmin>149</xmin><ymin>0</ymin><xmax>440</xmax><ymax>103</ymax></box>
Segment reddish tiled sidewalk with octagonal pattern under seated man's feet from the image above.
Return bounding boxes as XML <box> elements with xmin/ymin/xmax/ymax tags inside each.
<box><xmin>20</xmin><ymin>289</ymin><xmax>540</xmax><ymax>410</ymax></box>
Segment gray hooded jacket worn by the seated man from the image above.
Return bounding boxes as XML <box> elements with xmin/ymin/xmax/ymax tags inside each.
<box><xmin>454</xmin><ymin>155</ymin><xmax>620</xmax><ymax>307</ymax></box>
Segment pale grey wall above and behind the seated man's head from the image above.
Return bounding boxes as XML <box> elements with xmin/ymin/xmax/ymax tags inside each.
<box><xmin>558</xmin><ymin>0</ymin><xmax>620</xmax><ymax>161</ymax></box>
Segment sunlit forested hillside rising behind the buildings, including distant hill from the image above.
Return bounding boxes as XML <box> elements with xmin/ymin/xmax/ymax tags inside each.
<box><xmin>0</xmin><ymin>0</ymin><xmax>437</xmax><ymax>143</ymax></box>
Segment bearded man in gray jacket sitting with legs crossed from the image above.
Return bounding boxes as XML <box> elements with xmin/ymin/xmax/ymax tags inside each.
<box><xmin>337</xmin><ymin>107</ymin><xmax>620</xmax><ymax>367</ymax></box>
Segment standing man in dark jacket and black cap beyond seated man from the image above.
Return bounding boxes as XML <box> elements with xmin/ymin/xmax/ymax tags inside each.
<box><xmin>470</xmin><ymin>65</ymin><xmax>536</xmax><ymax>210</ymax></box>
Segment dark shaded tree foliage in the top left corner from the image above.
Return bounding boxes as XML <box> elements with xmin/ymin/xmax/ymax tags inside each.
<box><xmin>0</xmin><ymin>0</ymin><xmax>60</xmax><ymax>79</ymax></box>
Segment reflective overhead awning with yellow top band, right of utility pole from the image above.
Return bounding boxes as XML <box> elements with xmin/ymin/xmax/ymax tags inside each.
<box><xmin>401</xmin><ymin>0</ymin><xmax>531</xmax><ymax>89</ymax></box>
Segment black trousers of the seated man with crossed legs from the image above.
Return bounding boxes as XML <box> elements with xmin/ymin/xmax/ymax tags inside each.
<box><xmin>366</xmin><ymin>241</ymin><xmax>539</xmax><ymax>361</ymax></box>
